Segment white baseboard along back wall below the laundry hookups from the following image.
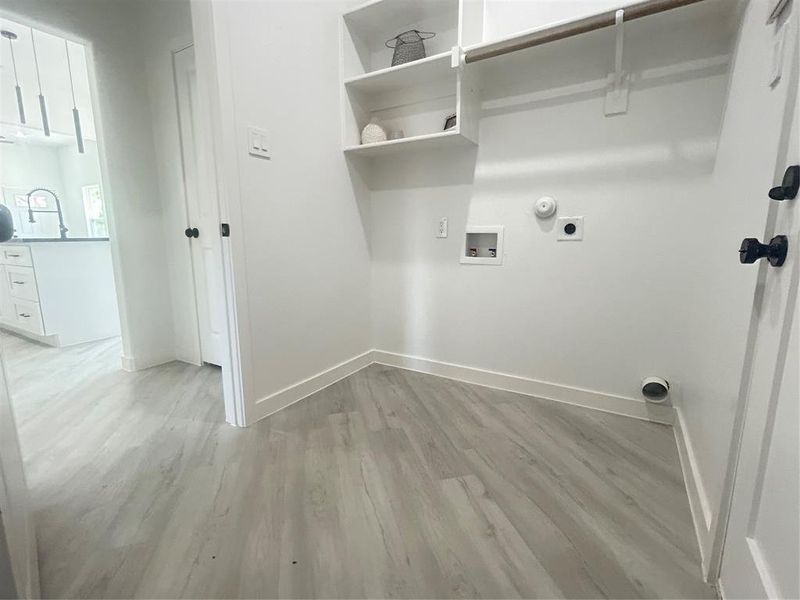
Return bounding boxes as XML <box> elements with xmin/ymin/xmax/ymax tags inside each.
<box><xmin>373</xmin><ymin>350</ymin><xmax>675</xmax><ymax>425</ymax></box>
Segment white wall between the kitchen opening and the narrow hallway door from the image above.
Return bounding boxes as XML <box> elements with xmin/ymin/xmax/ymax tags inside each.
<box><xmin>3</xmin><ymin>0</ymin><xmax>195</xmax><ymax>368</ymax></box>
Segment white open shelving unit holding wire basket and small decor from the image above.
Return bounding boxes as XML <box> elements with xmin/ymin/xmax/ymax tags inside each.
<box><xmin>341</xmin><ymin>0</ymin><xmax>483</xmax><ymax>157</ymax></box>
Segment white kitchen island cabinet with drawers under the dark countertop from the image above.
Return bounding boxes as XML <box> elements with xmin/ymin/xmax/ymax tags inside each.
<box><xmin>0</xmin><ymin>240</ymin><xmax>119</xmax><ymax>346</ymax></box>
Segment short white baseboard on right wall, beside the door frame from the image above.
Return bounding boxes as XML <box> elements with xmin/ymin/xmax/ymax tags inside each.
<box><xmin>673</xmin><ymin>407</ymin><xmax>713</xmax><ymax>575</ymax></box>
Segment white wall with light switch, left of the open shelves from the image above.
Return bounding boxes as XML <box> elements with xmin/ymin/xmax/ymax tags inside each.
<box><xmin>202</xmin><ymin>0</ymin><xmax>371</xmax><ymax>421</ymax></box>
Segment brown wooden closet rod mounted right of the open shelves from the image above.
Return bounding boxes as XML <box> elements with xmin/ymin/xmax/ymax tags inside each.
<box><xmin>464</xmin><ymin>0</ymin><xmax>704</xmax><ymax>63</ymax></box>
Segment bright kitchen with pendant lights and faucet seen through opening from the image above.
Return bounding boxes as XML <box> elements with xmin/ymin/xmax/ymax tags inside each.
<box><xmin>0</xmin><ymin>20</ymin><xmax>119</xmax><ymax>346</ymax></box>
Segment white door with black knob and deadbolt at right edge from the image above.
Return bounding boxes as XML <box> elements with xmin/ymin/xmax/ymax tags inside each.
<box><xmin>720</xmin><ymin>15</ymin><xmax>800</xmax><ymax>598</ymax></box>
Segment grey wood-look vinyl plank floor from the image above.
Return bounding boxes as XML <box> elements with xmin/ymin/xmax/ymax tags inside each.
<box><xmin>2</xmin><ymin>334</ymin><xmax>715</xmax><ymax>598</ymax></box>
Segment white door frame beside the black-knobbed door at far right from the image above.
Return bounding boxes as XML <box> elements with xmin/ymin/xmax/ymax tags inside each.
<box><xmin>704</xmin><ymin>4</ymin><xmax>800</xmax><ymax>584</ymax></box>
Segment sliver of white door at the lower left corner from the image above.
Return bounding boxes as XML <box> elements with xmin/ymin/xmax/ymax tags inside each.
<box><xmin>0</xmin><ymin>342</ymin><xmax>39</xmax><ymax>598</ymax></box>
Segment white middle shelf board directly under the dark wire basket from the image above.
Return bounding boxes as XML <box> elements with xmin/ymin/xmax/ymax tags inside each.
<box><xmin>344</xmin><ymin>52</ymin><xmax>452</xmax><ymax>94</ymax></box>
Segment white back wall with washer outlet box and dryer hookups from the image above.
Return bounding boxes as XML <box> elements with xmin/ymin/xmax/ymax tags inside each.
<box><xmin>372</xmin><ymin>7</ymin><xmax>735</xmax><ymax>399</ymax></box>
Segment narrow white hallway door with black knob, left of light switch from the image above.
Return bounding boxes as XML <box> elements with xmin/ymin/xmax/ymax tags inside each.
<box><xmin>175</xmin><ymin>46</ymin><xmax>225</xmax><ymax>365</ymax></box>
